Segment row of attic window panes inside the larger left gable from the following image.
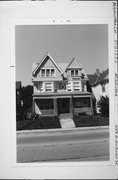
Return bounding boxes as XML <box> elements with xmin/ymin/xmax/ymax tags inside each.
<box><xmin>41</xmin><ymin>68</ymin><xmax>55</xmax><ymax>77</ymax></box>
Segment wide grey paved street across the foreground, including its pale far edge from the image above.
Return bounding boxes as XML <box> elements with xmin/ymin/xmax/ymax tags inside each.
<box><xmin>17</xmin><ymin>127</ymin><xmax>109</xmax><ymax>163</ymax></box>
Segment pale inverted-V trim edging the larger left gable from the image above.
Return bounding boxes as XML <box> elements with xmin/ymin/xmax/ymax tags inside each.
<box><xmin>32</xmin><ymin>53</ymin><xmax>63</xmax><ymax>75</ymax></box>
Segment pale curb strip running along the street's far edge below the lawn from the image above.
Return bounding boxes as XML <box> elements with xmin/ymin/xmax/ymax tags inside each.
<box><xmin>16</xmin><ymin>126</ymin><xmax>109</xmax><ymax>135</ymax></box>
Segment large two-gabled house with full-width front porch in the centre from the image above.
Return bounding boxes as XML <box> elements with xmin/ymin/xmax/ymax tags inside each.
<box><xmin>32</xmin><ymin>53</ymin><xmax>93</xmax><ymax>116</ymax></box>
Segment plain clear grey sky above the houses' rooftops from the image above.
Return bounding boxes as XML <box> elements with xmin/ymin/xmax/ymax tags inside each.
<box><xmin>15</xmin><ymin>24</ymin><xmax>108</xmax><ymax>86</ymax></box>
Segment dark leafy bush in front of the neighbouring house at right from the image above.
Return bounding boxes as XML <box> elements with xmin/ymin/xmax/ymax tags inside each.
<box><xmin>98</xmin><ymin>96</ymin><xmax>109</xmax><ymax>117</ymax></box>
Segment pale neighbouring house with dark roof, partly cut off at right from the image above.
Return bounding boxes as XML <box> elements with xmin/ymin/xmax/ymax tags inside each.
<box><xmin>87</xmin><ymin>69</ymin><xmax>109</xmax><ymax>111</ymax></box>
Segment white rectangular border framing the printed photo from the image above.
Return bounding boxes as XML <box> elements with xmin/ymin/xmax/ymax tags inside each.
<box><xmin>11</xmin><ymin>17</ymin><xmax>115</xmax><ymax>167</ymax></box>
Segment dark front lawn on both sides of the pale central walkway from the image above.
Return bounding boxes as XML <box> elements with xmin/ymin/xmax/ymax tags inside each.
<box><xmin>16</xmin><ymin>115</ymin><xmax>109</xmax><ymax>130</ymax></box>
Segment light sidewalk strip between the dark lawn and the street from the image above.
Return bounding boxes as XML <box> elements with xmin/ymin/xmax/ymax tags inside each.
<box><xmin>17</xmin><ymin>126</ymin><xmax>109</xmax><ymax>136</ymax></box>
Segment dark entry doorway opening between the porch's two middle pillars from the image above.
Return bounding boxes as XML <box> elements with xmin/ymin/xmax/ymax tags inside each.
<box><xmin>57</xmin><ymin>98</ymin><xmax>70</xmax><ymax>115</ymax></box>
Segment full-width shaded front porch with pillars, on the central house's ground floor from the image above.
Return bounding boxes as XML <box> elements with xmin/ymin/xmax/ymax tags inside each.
<box><xmin>33</xmin><ymin>92</ymin><xmax>93</xmax><ymax>117</ymax></box>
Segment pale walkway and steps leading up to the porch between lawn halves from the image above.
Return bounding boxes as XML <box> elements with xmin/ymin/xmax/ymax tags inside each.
<box><xmin>59</xmin><ymin>114</ymin><xmax>75</xmax><ymax>129</ymax></box>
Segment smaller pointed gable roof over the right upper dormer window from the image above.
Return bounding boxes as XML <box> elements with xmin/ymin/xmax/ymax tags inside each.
<box><xmin>65</xmin><ymin>58</ymin><xmax>82</xmax><ymax>71</ymax></box>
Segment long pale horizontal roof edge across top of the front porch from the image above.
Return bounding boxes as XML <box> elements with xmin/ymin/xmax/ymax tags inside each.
<box><xmin>33</xmin><ymin>91</ymin><xmax>92</xmax><ymax>98</ymax></box>
